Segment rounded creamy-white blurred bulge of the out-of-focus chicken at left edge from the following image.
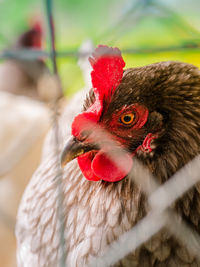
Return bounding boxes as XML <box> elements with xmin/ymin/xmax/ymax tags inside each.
<box><xmin>0</xmin><ymin>92</ymin><xmax>49</xmax><ymax>176</ymax></box>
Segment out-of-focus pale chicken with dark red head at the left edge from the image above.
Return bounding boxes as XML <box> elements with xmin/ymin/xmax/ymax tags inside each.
<box><xmin>0</xmin><ymin>21</ymin><xmax>50</xmax><ymax>267</ymax></box>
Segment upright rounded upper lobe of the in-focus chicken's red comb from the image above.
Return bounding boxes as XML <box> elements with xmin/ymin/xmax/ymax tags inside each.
<box><xmin>89</xmin><ymin>45</ymin><xmax>125</xmax><ymax>99</ymax></box>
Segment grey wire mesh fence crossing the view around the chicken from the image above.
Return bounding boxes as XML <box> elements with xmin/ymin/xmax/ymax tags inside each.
<box><xmin>0</xmin><ymin>0</ymin><xmax>200</xmax><ymax>267</ymax></box>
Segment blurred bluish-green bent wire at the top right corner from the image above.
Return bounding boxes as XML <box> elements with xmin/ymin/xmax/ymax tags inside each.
<box><xmin>96</xmin><ymin>0</ymin><xmax>199</xmax><ymax>44</ymax></box>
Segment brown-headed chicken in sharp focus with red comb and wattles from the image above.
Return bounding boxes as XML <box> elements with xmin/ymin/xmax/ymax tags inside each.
<box><xmin>16</xmin><ymin>46</ymin><xmax>200</xmax><ymax>266</ymax></box>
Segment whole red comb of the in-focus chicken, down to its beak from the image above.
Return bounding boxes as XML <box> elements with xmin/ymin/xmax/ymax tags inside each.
<box><xmin>72</xmin><ymin>45</ymin><xmax>125</xmax><ymax>137</ymax></box>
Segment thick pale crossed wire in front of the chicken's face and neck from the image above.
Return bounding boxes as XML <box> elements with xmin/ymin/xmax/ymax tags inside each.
<box><xmin>82</xmin><ymin>121</ymin><xmax>200</xmax><ymax>267</ymax></box>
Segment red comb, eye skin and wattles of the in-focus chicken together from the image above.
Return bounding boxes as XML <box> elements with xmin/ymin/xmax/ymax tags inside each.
<box><xmin>72</xmin><ymin>46</ymin><xmax>148</xmax><ymax>182</ymax></box>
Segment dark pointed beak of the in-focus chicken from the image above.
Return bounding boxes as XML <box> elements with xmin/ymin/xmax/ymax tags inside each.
<box><xmin>61</xmin><ymin>137</ymin><xmax>98</xmax><ymax>167</ymax></box>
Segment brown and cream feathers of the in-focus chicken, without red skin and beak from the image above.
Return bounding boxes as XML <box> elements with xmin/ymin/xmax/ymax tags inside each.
<box><xmin>16</xmin><ymin>59</ymin><xmax>200</xmax><ymax>267</ymax></box>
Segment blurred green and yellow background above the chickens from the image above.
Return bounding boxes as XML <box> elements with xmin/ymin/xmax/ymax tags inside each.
<box><xmin>0</xmin><ymin>0</ymin><xmax>200</xmax><ymax>95</ymax></box>
